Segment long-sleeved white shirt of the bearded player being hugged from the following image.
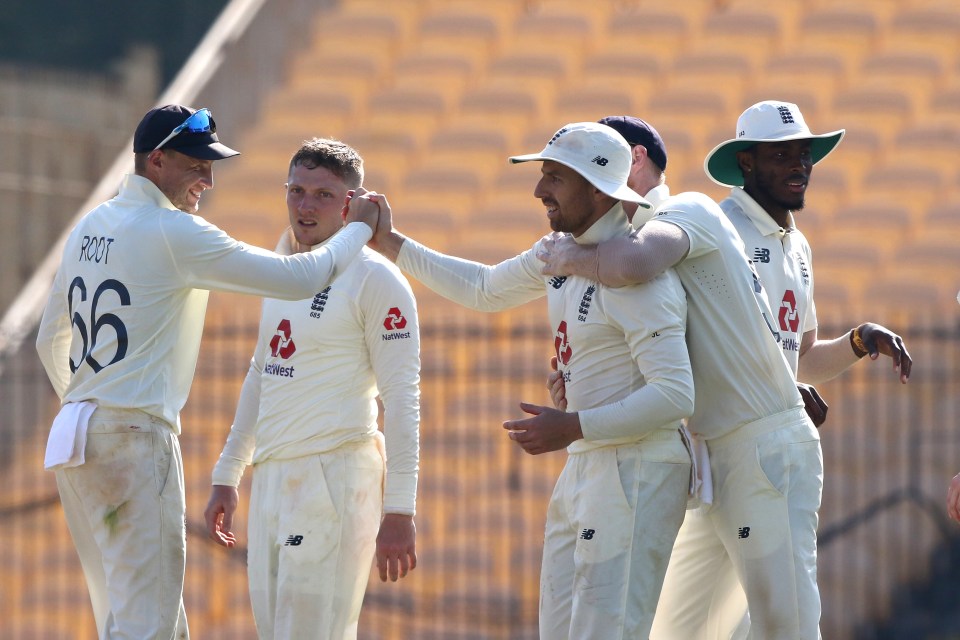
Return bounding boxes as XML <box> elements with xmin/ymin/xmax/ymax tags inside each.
<box><xmin>397</xmin><ymin>203</ymin><xmax>693</xmax><ymax>453</ymax></box>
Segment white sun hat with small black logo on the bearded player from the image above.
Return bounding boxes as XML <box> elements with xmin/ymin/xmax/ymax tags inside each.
<box><xmin>510</xmin><ymin>122</ymin><xmax>653</xmax><ymax>209</ymax></box>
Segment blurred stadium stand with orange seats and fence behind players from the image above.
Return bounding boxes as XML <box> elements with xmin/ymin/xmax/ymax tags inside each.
<box><xmin>0</xmin><ymin>0</ymin><xmax>960</xmax><ymax>640</ymax></box>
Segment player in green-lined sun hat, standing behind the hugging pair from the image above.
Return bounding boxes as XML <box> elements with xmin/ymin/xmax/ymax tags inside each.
<box><xmin>651</xmin><ymin>100</ymin><xmax>912</xmax><ymax>640</ymax></box>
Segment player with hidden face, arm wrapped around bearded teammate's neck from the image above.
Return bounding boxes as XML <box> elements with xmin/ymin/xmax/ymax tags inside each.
<box><xmin>542</xmin><ymin>158</ymin><xmax>823</xmax><ymax>639</ymax></box>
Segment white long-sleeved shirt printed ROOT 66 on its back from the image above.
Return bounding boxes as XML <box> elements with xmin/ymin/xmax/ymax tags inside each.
<box><xmin>37</xmin><ymin>175</ymin><xmax>371</xmax><ymax>433</ymax></box>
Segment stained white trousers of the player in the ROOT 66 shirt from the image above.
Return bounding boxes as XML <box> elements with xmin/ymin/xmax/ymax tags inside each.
<box><xmin>56</xmin><ymin>408</ymin><xmax>190</xmax><ymax>640</ymax></box>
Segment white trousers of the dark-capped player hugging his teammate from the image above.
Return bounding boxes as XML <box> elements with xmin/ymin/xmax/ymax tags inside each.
<box><xmin>650</xmin><ymin>408</ymin><xmax>823</xmax><ymax>640</ymax></box>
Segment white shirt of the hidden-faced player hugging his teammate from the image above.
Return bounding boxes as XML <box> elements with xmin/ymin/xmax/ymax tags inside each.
<box><xmin>654</xmin><ymin>192</ymin><xmax>803</xmax><ymax>439</ymax></box>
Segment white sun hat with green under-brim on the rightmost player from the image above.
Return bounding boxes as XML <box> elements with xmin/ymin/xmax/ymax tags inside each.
<box><xmin>703</xmin><ymin>100</ymin><xmax>846</xmax><ymax>187</ymax></box>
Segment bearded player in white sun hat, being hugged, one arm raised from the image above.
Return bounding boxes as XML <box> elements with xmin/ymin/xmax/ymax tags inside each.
<box><xmin>351</xmin><ymin>122</ymin><xmax>693</xmax><ymax>640</ymax></box>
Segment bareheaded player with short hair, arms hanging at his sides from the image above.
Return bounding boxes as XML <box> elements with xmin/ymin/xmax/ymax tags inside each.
<box><xmin>205</xmin><ymin>139</ymin><xmax>420</xmax><ymax>640</ymax></box>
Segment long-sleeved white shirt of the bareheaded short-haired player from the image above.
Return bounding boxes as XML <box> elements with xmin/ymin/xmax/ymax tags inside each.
<box><xmin>213</xmin><ymin>230</ymin><xmax>420</xmax><ymax>515</ymax></box>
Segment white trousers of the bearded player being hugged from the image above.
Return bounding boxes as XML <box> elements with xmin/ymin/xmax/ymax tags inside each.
<box><xmin>540</xmin><ymin>430</ymin><xmax>690</xmax><ymax>640</ymax></box>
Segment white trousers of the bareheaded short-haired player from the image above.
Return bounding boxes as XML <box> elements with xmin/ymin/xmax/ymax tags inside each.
<box><xmin>247</xmin><ymin>432</ymin><xmax>386</xmax><ymax>640</ymax></box>
